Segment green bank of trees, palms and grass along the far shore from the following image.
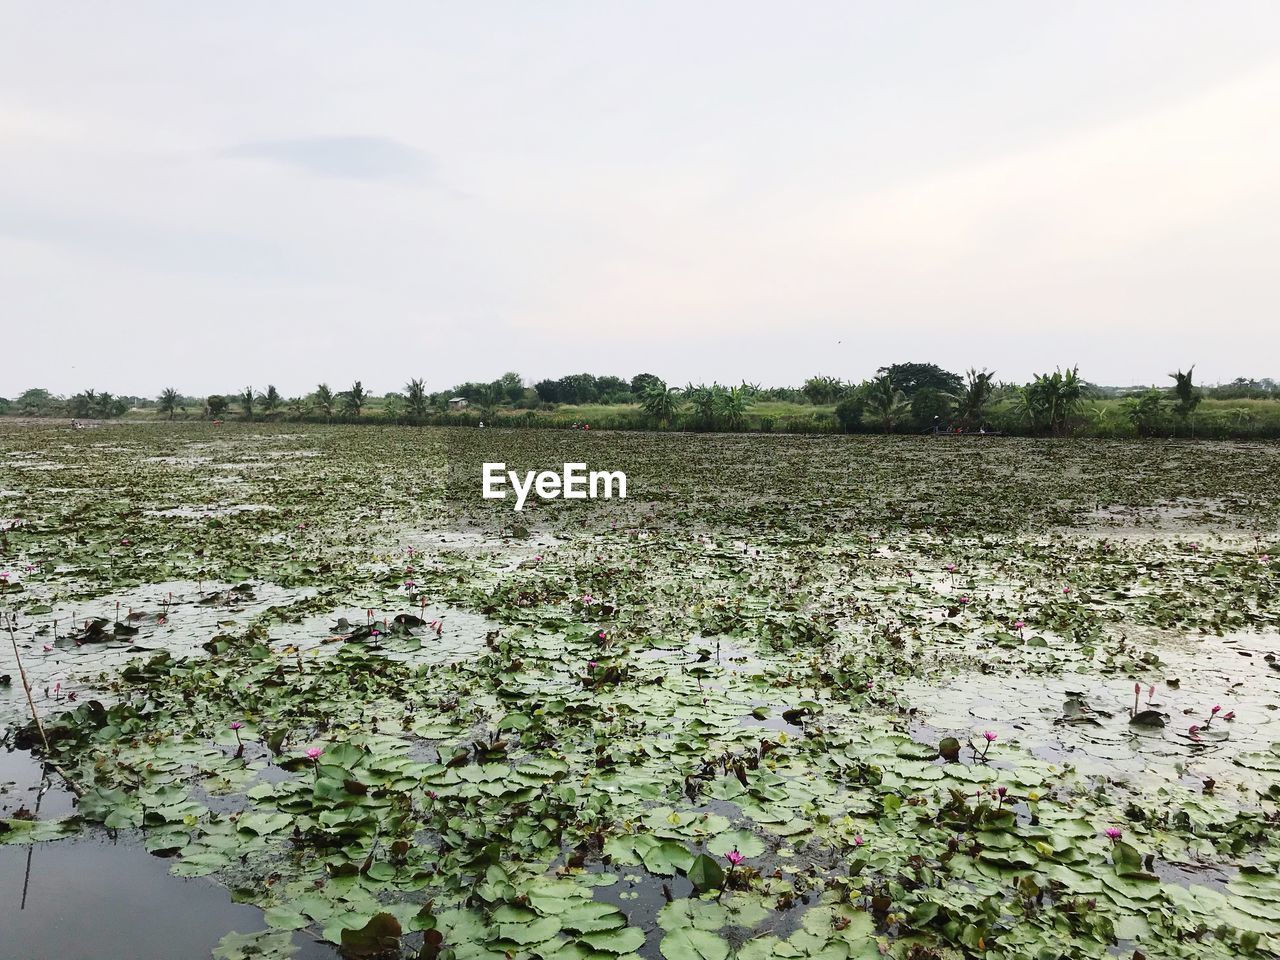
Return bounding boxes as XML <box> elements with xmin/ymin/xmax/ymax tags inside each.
<box><xmin>0</xmin><ymin>364</ymin><xmax>1280</xmax><ymax>439</ymax></box>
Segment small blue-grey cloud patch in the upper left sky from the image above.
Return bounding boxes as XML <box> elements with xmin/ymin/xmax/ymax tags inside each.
<box><xmin>223</xmin><ymin>137</ymin><xmax>431</xmax><ymax>180</ymax></box>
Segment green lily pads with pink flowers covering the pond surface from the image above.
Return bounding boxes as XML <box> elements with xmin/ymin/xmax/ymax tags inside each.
<box><xmin>0</xmin><ymin>425</ymin><xmax>1280</xmax><ymax>960</ymax></box>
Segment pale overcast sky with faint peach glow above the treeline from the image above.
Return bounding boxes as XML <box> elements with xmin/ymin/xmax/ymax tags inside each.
<box><xmin>0</xmin><ymin>0</ymin><xmax>1280</xmax><ymax>397</ymax></box>
